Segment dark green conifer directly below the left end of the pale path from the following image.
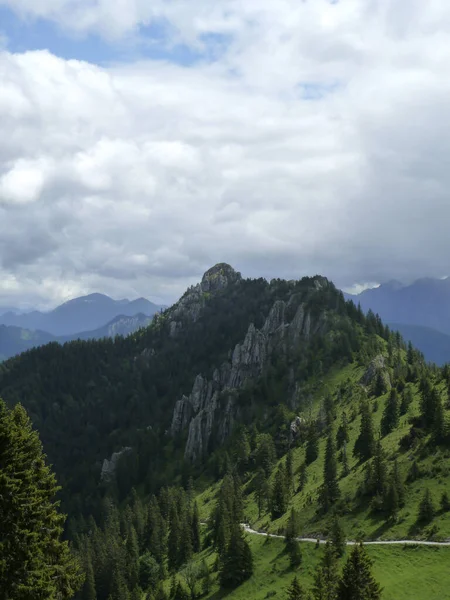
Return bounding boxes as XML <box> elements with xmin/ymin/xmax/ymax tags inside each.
<box><xmin>220</xmin><ymin>524</ymin><xmax>253</xmax><ymax>588</ymax></box>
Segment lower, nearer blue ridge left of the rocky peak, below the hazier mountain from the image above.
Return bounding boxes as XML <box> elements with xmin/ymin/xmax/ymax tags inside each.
<box><xmin>0</xmin><ymin>313</ymin><xmax>153</xmax><ymax>362</ymax></box>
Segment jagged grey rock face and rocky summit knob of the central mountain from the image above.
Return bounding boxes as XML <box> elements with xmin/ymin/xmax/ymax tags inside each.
<box><xmin>171</xmin><ymin>296</ymin><xmax>326</xmax><ymax>461</ymax></box>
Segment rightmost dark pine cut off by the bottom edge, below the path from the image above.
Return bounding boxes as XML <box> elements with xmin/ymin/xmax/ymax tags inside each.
<box><xmin>337</xmin><ymin>544</ymin><xmax>382</xmax><ymax>600</ymax></box>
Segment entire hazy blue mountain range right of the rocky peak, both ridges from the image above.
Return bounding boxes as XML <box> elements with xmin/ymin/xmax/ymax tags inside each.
<box><xmin>344</xmin><ymin>278</ymin><xmax>450</xmax><ymax>364</ymax></box>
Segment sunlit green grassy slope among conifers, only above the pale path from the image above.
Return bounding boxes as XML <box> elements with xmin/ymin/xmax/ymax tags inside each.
<box><xmin>199</xmin><ymin>364</ymin><xmax>450</xmax><ymax>540</ymax></box>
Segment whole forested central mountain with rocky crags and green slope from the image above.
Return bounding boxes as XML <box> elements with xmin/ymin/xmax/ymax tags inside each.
<box><xmin>0</xmin><ymin>264</ymin><xmax>450</xmax><ymax>600</ymax></box>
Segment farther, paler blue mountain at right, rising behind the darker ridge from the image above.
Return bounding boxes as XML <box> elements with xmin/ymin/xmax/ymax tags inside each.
<box><xmin>346</xmin><ymin>278</ymin><xmax>450</xmax><ymax>334</ymax></box>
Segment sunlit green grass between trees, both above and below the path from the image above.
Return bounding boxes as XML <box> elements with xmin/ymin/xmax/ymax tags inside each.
<box><xmin>191</xmin><ymin>364</ymin><xmax>450</xmax><ymax>600</ymax></box>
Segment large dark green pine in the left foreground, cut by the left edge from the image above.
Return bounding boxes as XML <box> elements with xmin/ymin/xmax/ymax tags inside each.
<box><xmin>0</xmin><ymin>400</ymin><xmax>83</xmax><ymax>600</ymax></box>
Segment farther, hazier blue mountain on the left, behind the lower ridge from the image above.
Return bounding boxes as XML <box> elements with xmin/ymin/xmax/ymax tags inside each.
<box><xmin>0</xmin><ymin>294</ymin><xmax>162</xmax><ymax>336</ymax></box>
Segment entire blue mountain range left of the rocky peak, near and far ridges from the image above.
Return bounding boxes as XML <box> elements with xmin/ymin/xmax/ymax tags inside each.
<box><xmin>0</xmin><ymin>294</ymin><xmax>164</xmax><ymax>361</ymax></box>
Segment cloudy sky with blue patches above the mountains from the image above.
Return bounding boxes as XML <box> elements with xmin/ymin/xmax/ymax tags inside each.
<box><xmin>0</xmin><ymin>0</ymin><xmax>450</xmax><ymax>308</ymax></box>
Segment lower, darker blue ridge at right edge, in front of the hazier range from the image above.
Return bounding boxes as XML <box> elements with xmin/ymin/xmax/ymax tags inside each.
<box><xmin>388</xmin><ymin>323</ymin><xmax>450</xmax><ymax>365</ymax></box>
